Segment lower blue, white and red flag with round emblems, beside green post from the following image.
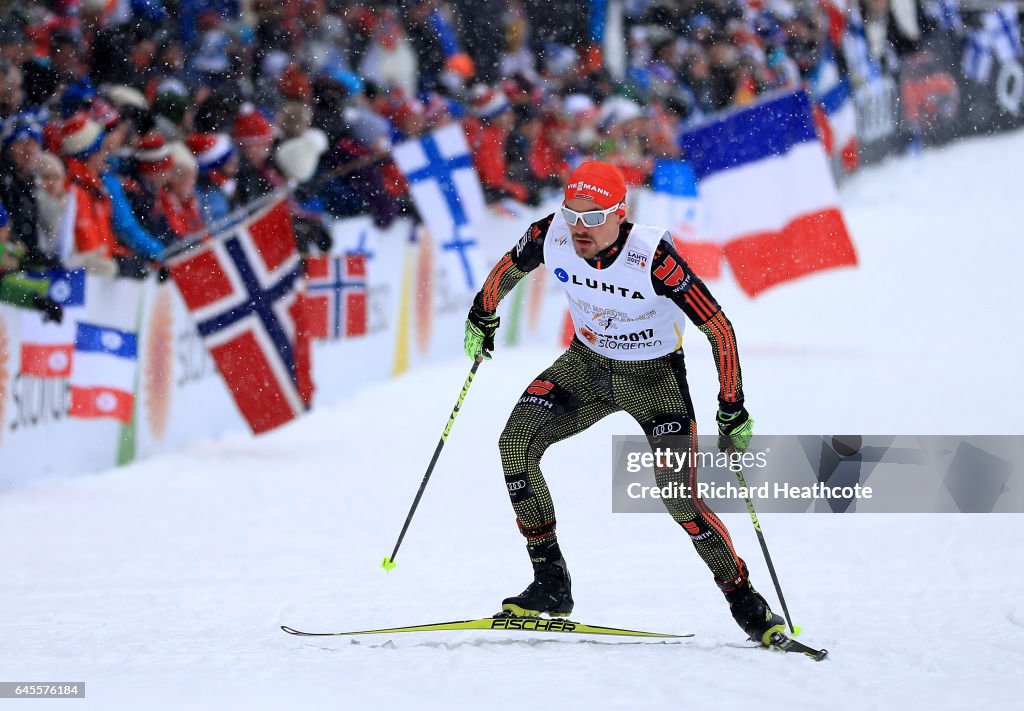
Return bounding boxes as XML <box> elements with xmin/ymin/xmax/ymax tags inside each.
<box><xmin>70</xmin><ymin>279</ymin><xmax>142</xmax><ymax>423</ymax></box>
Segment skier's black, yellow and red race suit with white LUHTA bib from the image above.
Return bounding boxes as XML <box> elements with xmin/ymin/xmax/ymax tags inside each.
<box><xmin>474</xmin><ymin>213</ymin><xmax>746</xmax><ymax>590</ymax></box>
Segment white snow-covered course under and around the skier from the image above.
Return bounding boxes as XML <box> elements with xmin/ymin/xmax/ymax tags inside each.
<box><xmin>6</xmin><ymin>132</ymin><xmax>1024</xmax><ymax>709</ymax></box>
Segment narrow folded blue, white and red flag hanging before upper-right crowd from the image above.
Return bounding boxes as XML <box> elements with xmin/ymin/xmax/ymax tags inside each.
<box><xmin>808</xmin><ymin>46</ymin><xmax>858</xmax><ymax>172</ymax></box>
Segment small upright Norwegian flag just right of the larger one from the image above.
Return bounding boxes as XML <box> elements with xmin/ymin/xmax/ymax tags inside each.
<box><xmin>304</xmin><ymin>253</ymin><xmax>367</xmax><ymax>340</ymax></box>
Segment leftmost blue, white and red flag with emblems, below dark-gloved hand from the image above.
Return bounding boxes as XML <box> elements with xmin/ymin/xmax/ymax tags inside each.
<box><xmin>22</xmin><ymin>269</ymin><xmax>85</xmax><ymax>378</ymax></box>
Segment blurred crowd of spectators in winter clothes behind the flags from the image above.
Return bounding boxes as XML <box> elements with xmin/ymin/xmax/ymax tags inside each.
<box><xmin>0</xmin><ymin>0</ymin><xmax>999</xmax><ymax>320</ymax></box>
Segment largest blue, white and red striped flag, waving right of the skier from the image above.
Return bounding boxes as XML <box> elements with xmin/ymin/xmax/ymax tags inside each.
<box><xmin>682</xmin><ymin>91</ymin><xmax>857</xmax><ymax>296</ymax></box>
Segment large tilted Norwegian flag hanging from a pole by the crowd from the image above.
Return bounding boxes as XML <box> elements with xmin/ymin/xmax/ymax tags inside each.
<box><xmin>169</xmin><ymin>198</ymin><xmax>312</xmax><ymax>433</ymax></box>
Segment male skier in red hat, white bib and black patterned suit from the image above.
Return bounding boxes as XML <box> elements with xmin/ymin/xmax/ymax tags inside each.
<box><xmin>465</xmin><ymin>161</ymin><xmax>784</xmax><ymax>646</ymax></box>
